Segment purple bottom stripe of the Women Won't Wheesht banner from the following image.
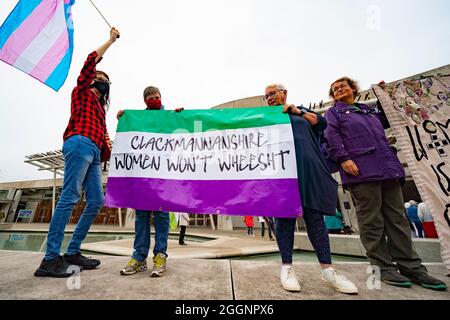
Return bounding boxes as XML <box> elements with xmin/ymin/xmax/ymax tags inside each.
<box><xmin>106</xmin><ymin>177</ymin><xmax>303</xmax><ymax>218</ymax></box>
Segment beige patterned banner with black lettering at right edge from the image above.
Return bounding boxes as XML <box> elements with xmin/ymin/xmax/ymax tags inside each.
<box><xmin>373</xmin><ymin>75</ymin><xmax>450</xmax><ymax>271</ymax></box>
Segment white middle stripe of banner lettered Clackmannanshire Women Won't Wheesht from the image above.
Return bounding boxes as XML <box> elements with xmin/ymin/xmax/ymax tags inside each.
<box><xmin>109</xmin><ymin>124</ymin><xmax>297</xmax><ymax>180</ymax></box>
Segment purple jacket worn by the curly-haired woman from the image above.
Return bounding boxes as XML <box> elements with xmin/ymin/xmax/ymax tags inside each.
<box><xmin>325</xmin><ymin>102</ymin><xmax>405</xmax><ymax>185</ymax></box>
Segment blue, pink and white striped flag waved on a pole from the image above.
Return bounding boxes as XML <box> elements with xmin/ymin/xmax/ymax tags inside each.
<box><xmin>0</xmin><ymin>0</ymin><xmax>75</xmax><ymax>91</ymax></box>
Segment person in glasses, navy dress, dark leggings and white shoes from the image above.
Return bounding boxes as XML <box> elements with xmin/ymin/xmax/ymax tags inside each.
<box><xmin>264</xmin><ymin>84</ymin><xmax>358</xmax><ymax>294</ymax></box>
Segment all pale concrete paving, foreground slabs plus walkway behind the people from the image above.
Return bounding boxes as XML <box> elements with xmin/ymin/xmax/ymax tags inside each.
<box><xmin>0</xmin><ymin>224</ymin><xmax>450</xmax><ymax>300</ymax></box>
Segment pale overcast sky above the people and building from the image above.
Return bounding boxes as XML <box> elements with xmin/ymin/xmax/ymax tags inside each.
<box><xmin>0</xmin><ymin>0</ymin><xmax>450</xmax><ymax>182</ymax></box>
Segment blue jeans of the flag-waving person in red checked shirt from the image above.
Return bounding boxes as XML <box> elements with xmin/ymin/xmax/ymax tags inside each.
<box><xmin>44</xmin><ymin>135</ymin><xmax>104</xmax><ymax>261</ymax></box>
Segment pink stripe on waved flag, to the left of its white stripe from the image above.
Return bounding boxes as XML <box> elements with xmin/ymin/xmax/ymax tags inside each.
<box><xmin>0</xmin><ymin>0</ymin><xmax>58</xmax><ymax>65</ymax></box>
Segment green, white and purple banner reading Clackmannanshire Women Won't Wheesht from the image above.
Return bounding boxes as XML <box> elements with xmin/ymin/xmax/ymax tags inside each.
<box><xmin>106</xmin><ymin>107</ymin><xmax>302</xmax><ymax>217</ymax></box>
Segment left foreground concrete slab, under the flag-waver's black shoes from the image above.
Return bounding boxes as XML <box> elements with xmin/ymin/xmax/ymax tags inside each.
<box><xmin>0</xmin><ymin>251</ymin><xmax>233</xmax><ymax>300</ymax></box>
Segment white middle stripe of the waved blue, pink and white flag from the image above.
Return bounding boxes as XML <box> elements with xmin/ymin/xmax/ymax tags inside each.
<box><xmin>14</xmin><ymin>1</ymin><xmax>67</xmax><ymax>73</ymax></box>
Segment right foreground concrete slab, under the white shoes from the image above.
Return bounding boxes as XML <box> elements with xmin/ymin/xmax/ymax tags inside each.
<box><xmin>231</xmin><ymin>261</ymin><xmax>450</xmax><ymax>300</ymax></box>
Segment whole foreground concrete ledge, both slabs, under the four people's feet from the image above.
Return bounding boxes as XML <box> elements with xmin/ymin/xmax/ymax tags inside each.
<box><xmin>0</xmin><ymin>251</ymin><xmax>450</xmax><ymax>300</ymax></box>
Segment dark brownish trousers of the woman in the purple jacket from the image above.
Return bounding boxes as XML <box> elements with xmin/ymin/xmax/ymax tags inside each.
<box><xmin>348</xmin><ymin>180</ymin><xmax>427</xmax><ymax>273</ymax></box>
